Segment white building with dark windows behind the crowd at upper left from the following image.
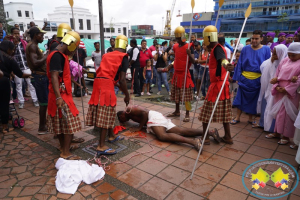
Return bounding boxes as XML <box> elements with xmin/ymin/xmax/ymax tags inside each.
<box><xmin>4</xmin><ymin>2</ymin><xmax>129</xmax><ymax>39</ymax></box>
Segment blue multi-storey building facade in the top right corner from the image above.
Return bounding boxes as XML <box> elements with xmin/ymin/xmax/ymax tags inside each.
<box><xmin>212</xmin><ymin>0</ymin><xmax>300</xmax><ymax>36</ymax></box>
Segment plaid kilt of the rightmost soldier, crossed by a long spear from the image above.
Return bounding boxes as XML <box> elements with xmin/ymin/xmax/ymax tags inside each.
<box><xmin>198</xmin><ymin>99</ymin><xmax>232</xmax><ymax>123</ymax></box>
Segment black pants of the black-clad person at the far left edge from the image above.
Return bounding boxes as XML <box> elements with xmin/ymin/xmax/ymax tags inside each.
<box><xmin>0</xmin><ymin>77</ymin><xmax>10</xmax><ymax>124</ymax></box>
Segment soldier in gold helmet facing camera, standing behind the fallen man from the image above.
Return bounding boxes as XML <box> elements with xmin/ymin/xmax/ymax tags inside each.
<box><xmin>167</xmin><ymin>26</ymin><xmax>194</xmax><ymax>122</ymax></box>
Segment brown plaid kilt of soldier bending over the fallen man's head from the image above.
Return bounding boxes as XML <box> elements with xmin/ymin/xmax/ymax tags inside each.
<box><xmin>86</xmin><ymin>105</ymin><xmax>117</xmax><ymax>129</ymax></box>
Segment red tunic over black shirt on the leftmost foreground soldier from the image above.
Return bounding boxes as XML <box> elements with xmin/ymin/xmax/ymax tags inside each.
<box><xmin>47</xmin><ymin>51</ymin><xmax>79</xmax><ymax>117</ymax></box>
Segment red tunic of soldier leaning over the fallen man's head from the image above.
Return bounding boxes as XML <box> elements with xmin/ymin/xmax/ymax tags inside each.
<box><xmin>89</xmin><ymin>51</ymin><xmax>127</xmax><ymax>106</ymax></box>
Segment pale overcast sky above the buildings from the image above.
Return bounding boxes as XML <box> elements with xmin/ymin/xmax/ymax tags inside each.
<box><xmin>4</xmin><ymin>0</ymin><xmax>214</xmax><ymax>31</ymax></box>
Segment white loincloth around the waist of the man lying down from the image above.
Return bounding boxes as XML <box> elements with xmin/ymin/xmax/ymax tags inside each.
<box><xmin>147</xmin><ymin>110</ymin><xmax>176</xmax><ymax>133</ymax></box>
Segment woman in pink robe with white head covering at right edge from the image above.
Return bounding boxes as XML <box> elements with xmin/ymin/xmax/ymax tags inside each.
<box><xmin>266</xmin><ymin>42</ymin><xmax>300</xmax><ymax>144</ymax></box>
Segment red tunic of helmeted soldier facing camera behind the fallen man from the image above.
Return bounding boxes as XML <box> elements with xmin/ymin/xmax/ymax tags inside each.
<box><xmin>172</xmin><ymin>43</ymin><xmax>194</xmax><ymax>88</ymax></box>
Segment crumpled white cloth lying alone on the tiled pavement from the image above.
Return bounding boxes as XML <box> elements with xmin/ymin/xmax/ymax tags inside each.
<box><xmin>55</xmin><ymin>158</ymin><xmax>105</xmax><ymax>194</ymax></box>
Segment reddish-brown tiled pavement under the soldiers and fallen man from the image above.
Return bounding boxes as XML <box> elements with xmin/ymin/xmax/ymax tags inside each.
<box><xmin>0</xmin><ymin>97</ymin><xmax>300</xmax><ymax>200</ymax></box>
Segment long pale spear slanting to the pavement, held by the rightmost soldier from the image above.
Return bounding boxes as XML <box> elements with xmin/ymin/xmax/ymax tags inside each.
<box><xmin>191</xmin><ymin>3</ymin><xmax>251</xmax><ymax>179</ymax></box>
